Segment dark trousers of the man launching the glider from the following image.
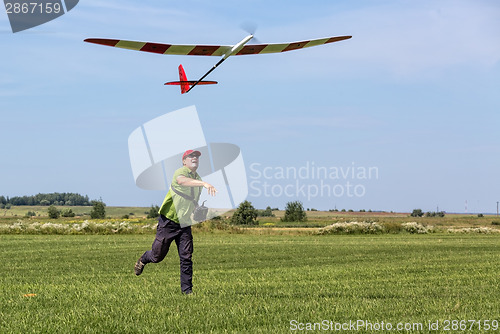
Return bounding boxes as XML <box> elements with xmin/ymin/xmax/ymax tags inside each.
<box><xmin>141</xmin><ymin>215</ymin><xmax>193</xmax><ymax>292</ymax></box>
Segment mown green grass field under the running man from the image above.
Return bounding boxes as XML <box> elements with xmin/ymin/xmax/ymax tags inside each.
<box><xmin>0</xmin><ymin>232</ymin><xmax>500</xmax><ymax>333</ymax></box>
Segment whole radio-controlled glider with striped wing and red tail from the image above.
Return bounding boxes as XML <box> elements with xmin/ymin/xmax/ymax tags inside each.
<box><xmin>85</xmin><ymin>34</ymin><xmax>352</xmax><ymax>94</ymax></box>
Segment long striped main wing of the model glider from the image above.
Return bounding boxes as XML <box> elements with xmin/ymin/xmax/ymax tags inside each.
<box><xmin>85</xmin><ymin>36</ymin><xmax>352</xmax><ymax>56</ymax></box>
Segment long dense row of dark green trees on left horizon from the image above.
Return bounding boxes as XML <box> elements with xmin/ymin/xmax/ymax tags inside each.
<box><xmin>0</xmin><ymin>193</ymin><xmax>92</xmax><ymax>207</ymax></box>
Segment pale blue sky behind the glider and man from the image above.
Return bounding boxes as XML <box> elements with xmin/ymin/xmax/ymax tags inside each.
<box><xmin>0</xmin><ymin>0</ymin><xmax>500</xmax><ymax>212</ymax></box>
